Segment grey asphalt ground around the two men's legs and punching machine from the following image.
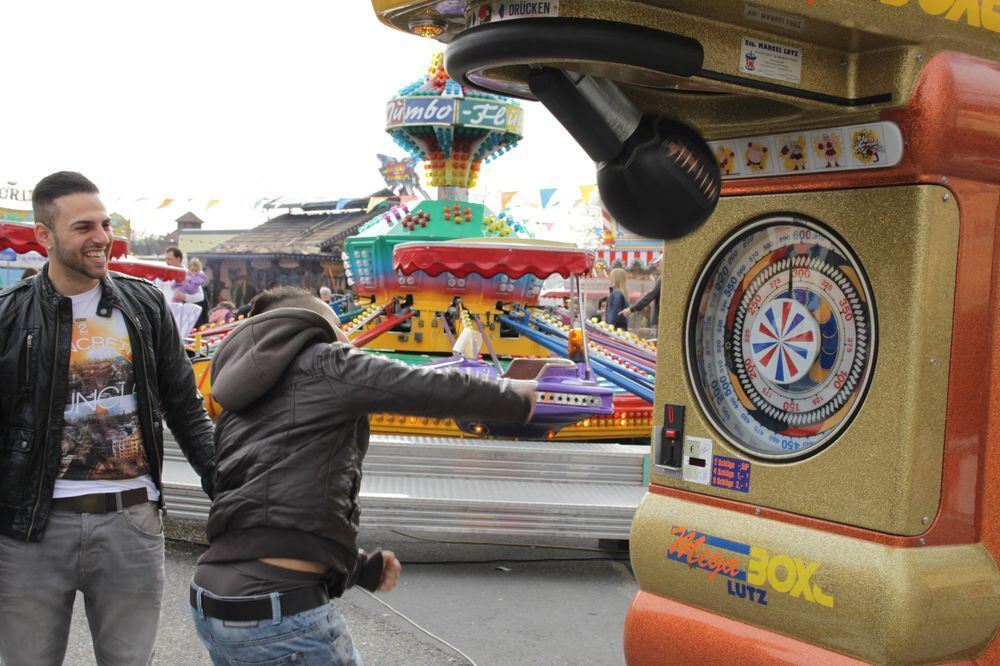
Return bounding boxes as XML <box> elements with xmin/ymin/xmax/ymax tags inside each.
<box><xmin>65</xmin><ymin>527</ymin><xmax>638</xmax><ymax>666</ymax></box>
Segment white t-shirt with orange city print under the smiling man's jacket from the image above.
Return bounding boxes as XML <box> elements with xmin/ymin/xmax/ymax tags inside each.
<box><xmin>54</xmin><ymin>284</ymin><xmax>160</xmax><ymax>501</ymax></box>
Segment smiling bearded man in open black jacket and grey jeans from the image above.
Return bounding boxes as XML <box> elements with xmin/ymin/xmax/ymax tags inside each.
<box><xmin>0</xmin><ymin>172</ymin><xmax>215</xmax><ymax>666</ymax></box>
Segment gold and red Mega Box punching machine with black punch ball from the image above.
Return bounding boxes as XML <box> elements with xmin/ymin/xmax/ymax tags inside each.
<box><xmin>373</xmin><ymin>0</ymin><xmax>1000</xmax><ymax>664</ymax></box>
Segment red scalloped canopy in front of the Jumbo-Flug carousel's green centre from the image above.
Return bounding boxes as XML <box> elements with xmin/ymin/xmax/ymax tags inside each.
<box><xmin>392</xmin><ymin>241</ymin><xmax>594</xmax><ymax>279</ymax></box>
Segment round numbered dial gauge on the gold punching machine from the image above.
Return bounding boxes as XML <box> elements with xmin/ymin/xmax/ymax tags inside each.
<box><xmin>687</xmin><ymin>216</ymin><xmax>876</xmax><ymax>460</ymax></box>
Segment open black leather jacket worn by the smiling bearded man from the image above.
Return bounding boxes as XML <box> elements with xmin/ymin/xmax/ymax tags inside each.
<box><xmin>0</xmin><ymin>264</ymin><xmax>215</xmax><ymax>541</ymax></box>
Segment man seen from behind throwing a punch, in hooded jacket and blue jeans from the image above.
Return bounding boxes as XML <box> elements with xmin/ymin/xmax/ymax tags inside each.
<box><xmin>191</xmin><ymin>287</ymin><xmax>535</xmax><ymax>664</ymax></box>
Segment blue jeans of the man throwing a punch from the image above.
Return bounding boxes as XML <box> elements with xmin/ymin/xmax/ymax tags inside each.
<box><xmin>191</xmin><ymin>583</ymin><xmax>362</xmax><ymax>666</ymax></box>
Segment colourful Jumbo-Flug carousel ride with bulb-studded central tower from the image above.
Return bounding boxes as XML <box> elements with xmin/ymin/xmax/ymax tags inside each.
<box><xmin>192</xmin><ymin>55</ymin><xmax>656</xmax><ymax>441</ymax></box>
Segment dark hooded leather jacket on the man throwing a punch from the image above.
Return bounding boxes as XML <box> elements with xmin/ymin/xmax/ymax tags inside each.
<box><xmin>201</xmin><ymin>308</ymin><xmax>531</xmax><ymax>580</ymax></box>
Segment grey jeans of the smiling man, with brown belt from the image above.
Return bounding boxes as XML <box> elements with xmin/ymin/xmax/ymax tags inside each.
<box><xmin>0</xmin><ymin>502</ymin><xmax>163</xmax><ymax>666</ymax></box>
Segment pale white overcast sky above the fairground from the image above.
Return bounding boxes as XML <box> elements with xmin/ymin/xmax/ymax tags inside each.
<box><xmin>0</xmin><ymin>0</ymin><xmax>594</xmax><ymax>231</ymax></box>
